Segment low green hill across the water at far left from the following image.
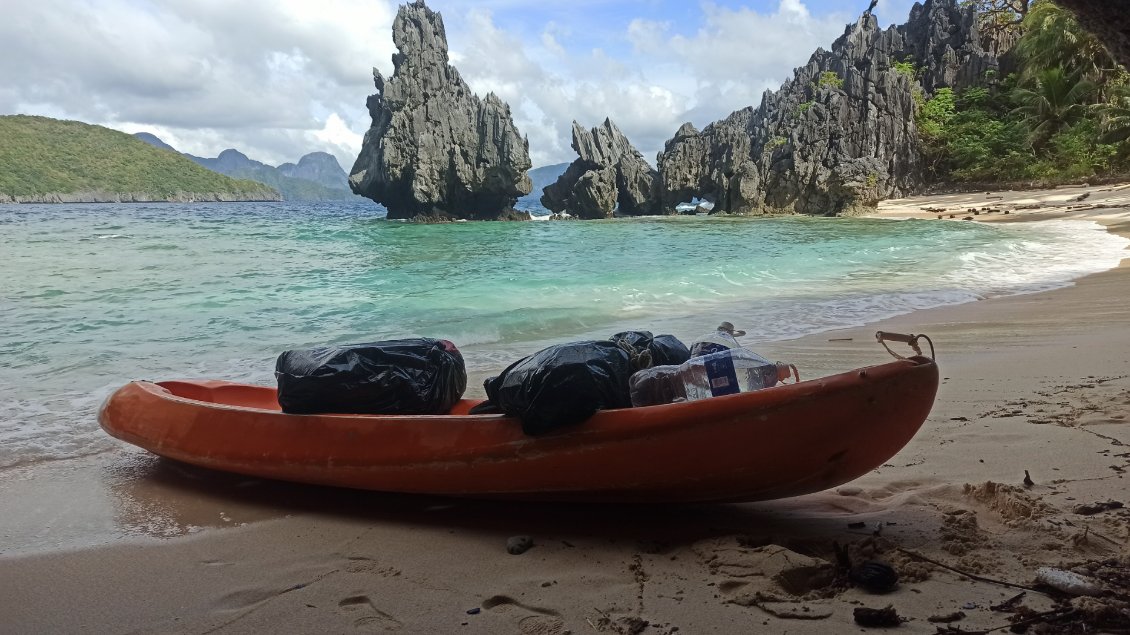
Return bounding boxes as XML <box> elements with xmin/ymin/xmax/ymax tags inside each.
<box><xmin>0</xmin><ymin>115</ymin><xmax>278</xmax><ymax>200</ymax></box>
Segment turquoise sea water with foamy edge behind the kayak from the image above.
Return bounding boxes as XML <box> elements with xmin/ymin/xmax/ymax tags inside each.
<box><xmin>0</xmin><ymin>201</ymin><xmax>1127</xmax><ymax>468</ymax></box>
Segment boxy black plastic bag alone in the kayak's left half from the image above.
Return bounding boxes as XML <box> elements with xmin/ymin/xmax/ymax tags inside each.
<box><xmin>275</xmin><ymin>338</ymin><xmax>467</xmax><ymax>415</ymax></box>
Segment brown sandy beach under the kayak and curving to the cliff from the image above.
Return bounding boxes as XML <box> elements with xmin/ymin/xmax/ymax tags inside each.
<box><xmin>0</xmin><ymin>180</ymin><xmax>1130</xmax><ymax>635</ymax></box>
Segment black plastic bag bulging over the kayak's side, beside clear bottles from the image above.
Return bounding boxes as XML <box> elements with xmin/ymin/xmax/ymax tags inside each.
<box><xmin>473</xmin><ymin>341</ymin><xmax>633</xmax><ymax>435</ymax></box>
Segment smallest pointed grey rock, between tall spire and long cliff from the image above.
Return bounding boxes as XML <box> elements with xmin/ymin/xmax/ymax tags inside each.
<box><xmin>541</xmin><ymin>119</ymin><xmax>659</xmax><ymax>218</ymax></box>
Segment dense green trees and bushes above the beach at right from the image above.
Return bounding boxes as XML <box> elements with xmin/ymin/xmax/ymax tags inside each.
<box><xmin>915</xmin><ymin>0</ymin><xmax>1130</xmax><ymax>184</ymax></box>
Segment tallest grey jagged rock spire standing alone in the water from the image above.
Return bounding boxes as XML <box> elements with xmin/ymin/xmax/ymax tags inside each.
<box><xmin>349</xmin><ymin>0</ymin><xmax>531</xmax><ymax>219</ymax></box>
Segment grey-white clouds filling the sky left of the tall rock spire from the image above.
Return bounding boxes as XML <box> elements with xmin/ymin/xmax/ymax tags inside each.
<box><xmin>0</xmin><ymin>0</ymin><xmax>394</xmax><ymax>167</ymax></box>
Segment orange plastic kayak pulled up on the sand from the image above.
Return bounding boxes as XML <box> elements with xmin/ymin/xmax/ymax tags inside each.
<box><xmin>98</xmin><ymin>357</ymin><xmax>938</xmax><ymax>502</ymax></box>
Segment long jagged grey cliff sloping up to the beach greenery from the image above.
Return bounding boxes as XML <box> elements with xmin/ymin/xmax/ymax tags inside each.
<box><xmin>659</xmin><ymin>0</ymin><xmax>998</xmax><ymax>215</ymax></box>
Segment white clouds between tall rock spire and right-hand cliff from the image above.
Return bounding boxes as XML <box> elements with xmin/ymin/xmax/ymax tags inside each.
<box><xmin>449</xmin><ymin>0</ymin><xmax>850</xmax><ymax>165</ymax></box>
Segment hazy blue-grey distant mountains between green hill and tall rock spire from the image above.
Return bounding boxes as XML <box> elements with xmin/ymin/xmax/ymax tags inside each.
<box><xmin>134</xmin><ymin>132</ymin><xmax>355</xmax><ymax>201</ymax></box>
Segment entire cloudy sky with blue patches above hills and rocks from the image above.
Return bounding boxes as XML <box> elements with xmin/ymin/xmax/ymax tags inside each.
<box><xmin>0</xmin><ymin>0</ymin><xmax>912</xmax><ymax>172</ymax></box>
